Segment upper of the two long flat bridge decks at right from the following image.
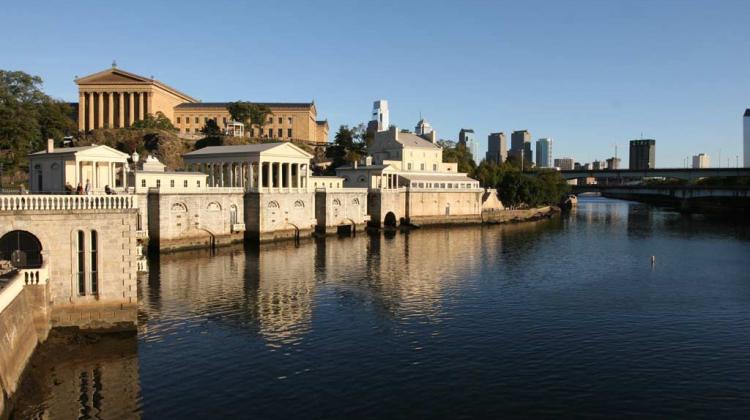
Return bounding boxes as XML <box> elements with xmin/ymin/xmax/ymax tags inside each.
<box><xmin>560</xmin><ymin>168</ymin><xmax>750</xmax><ymax>181</ymax></box>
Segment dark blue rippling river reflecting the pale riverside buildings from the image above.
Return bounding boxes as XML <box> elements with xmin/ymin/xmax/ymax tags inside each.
<box><xmin>8</xmin><ymin>198</ymin><xmax>750</xmax><ymax>419</ymax></box>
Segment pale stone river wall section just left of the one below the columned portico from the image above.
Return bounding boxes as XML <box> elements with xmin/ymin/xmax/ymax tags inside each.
<box><xmin>147</xmin><ymin>190</ymin><xmax>245</xmax><ymax>251</ymax></box>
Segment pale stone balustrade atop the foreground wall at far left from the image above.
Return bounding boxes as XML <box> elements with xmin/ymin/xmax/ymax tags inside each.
<box><xmin>0</xmin><ymin>194</ymin><xmax>138</xmax><ymax>211</ymax></box>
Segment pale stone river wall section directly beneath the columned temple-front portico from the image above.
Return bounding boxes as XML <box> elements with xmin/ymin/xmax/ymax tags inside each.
<box><xmin>245</xmin><ymin>192</ymin><xmax>316</xmax><ymax>242</ymax></box>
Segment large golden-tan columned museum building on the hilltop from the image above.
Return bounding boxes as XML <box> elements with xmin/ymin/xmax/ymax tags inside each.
<box><xmin>75</xmin><ymin>66</ymin><xmax>328</xmax><ymax>144</ymax></box>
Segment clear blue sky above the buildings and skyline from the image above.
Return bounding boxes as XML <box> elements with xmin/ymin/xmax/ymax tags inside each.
<box><xmin>0</xmin><ymin>0</ymin><xmax>750</xmax><ymax>167</ymax></box>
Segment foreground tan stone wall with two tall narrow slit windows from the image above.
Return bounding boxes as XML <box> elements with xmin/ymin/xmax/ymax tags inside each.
<box><xmin>0</xmin><ymin>208</ymin><xmax>137</xmax><ymax>329</ymax></box>
